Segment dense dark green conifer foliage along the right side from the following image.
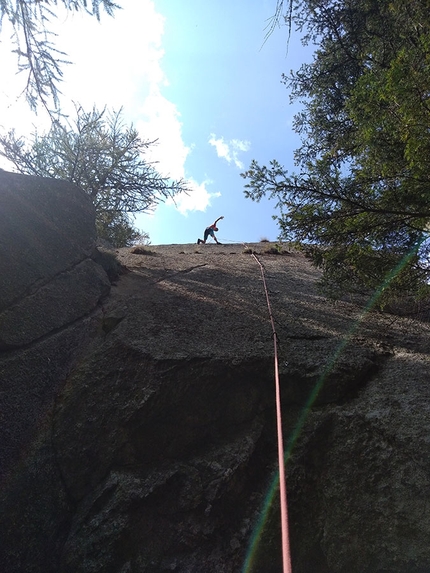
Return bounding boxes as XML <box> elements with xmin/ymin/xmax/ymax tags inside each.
<box><xmin>242</xmin><ymin>0</ymin><xmax>430</xmax><ymax>304</ymax></box>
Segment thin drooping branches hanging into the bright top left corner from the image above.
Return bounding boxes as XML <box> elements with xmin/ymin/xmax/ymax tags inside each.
<box><xmin>0</xmin><ymin>0</ymin><xmax>119</xmax><ymax>113</ymax></box>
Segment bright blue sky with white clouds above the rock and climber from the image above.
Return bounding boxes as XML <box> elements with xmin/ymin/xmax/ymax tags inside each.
<box><xmin>0</xmin><ymin>0</ymin><xmax>312</xmax><ymax>245</ymax></box>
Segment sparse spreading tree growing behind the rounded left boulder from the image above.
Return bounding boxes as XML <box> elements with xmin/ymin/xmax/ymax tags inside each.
<box><xmin>0</xmin><ymin>107</ymin><xmax>187</xmax><ymax>246</ymax></box>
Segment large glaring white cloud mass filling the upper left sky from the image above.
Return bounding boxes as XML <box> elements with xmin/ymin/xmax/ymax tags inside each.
<box><xmin>0</xmin><ymin>0</ymin><xmax>212</xmax><ymax>214</ymax></box>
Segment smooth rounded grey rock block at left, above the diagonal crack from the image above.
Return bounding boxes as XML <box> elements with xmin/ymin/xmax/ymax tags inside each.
<box><xmin>0</xmin><ymin>171</ymin><xmax>95</xmax><ymax>311</ymax></box>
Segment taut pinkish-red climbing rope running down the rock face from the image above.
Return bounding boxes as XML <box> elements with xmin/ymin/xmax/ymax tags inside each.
<box><xmin>252</xmin><ymin>253</ymin><xmax>291</xmax><ymax>573</ymax></box>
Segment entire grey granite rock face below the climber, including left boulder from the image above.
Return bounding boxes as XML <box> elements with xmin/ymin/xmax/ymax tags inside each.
<box><xmin>0</xmin><ymin>170</ymin><xmax>430</xmax><ymax>573</ymax></box>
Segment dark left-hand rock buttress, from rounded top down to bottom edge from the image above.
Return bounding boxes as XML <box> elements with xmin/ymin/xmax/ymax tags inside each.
<box><xmin>0</xmin><ymin>171</ymin><xmax>110</xmax><ymax>573</ymax></box>
